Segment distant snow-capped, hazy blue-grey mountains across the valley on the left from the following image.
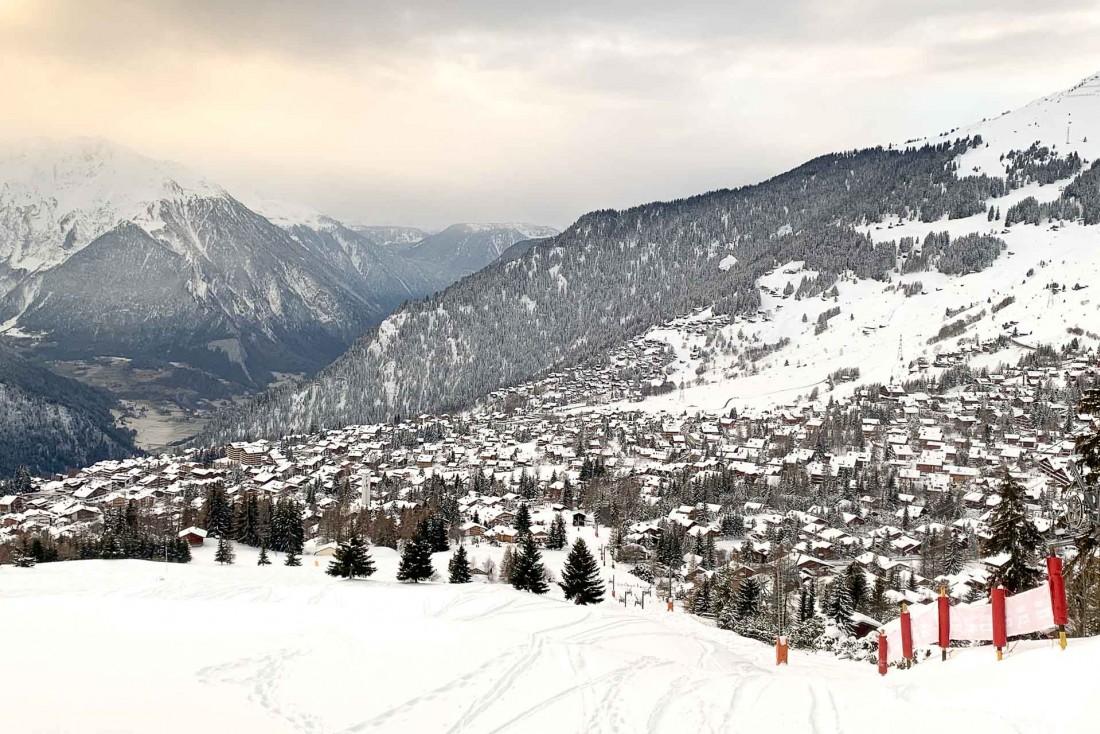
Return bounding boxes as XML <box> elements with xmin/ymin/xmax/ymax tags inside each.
<box><xmin>0</xmin><ymin>140</ymin><xmax>551</xmax><ymax>386</ymax></box>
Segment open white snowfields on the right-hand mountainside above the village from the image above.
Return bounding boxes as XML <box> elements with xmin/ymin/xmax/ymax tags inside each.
<box><xmin>602</xmin><ymin>70</ymin><xmax>1100</xmax><ymax>422</ymax></box>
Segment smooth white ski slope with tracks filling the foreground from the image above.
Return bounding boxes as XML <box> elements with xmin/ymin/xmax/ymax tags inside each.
<box><xmin>0</xmin><ymin>543</ymin><xmax>1100</xmax><ymax>734</ymax></box>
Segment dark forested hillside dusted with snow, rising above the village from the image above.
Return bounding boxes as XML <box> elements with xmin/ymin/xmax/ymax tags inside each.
<box><xmin>204</xmin><ymin>136</ymin><xmax>1051</xmax><ymax>440</ymax></box>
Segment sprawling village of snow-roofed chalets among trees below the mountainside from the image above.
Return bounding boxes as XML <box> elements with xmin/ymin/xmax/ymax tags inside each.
<box><xmin>0</xmin><ymin>321</ymin><xmax>1100</xmax><ymax>633</ymax></box>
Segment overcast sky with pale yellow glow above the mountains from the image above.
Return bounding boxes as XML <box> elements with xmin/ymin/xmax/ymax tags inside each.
<box><xmin>0</xmin><ymin>0</ymin><xmax>1100</xmax><ymax>227</ymax></box>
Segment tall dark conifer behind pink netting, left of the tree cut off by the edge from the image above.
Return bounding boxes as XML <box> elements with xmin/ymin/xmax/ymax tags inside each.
<box><xmin>986</xmin><ymin>472</ymin><xmax>1043</xmax><ymax>593</ymax></box>
